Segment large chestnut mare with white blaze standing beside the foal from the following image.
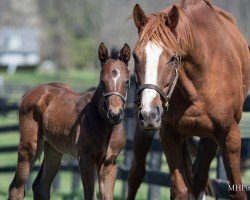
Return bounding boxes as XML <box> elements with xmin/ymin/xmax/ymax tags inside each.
<box><xmin>128</xmin><ymin>0</ymin><xmax>250</xmax><ymax>199</ymax></box>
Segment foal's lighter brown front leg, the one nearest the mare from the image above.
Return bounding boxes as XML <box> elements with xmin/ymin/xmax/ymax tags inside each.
<box><xmin>98</xmin><ymin>157</ymin><xmax>117</xmax><ymax>200</ymax></box>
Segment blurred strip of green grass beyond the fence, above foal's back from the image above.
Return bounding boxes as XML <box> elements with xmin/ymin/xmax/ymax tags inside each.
<box><xmin>0</xmin><ymin>69</ymin><xmax>99</xmax><ymax>102</ymax></box>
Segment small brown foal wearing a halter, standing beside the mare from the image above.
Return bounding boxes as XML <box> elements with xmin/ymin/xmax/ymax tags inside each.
<box><xmin>9</xmin><ymin>43</ymin><xmax>130</xmax><ymax>200</ymax></box>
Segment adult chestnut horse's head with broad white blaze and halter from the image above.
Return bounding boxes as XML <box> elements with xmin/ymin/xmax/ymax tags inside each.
<box><xmin>133</xmin><ymin>4</ymin><xmax>192</xmax><ymax>129</ymax></box>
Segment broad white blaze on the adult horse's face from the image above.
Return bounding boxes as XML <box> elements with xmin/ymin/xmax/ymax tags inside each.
<box><xmin>142</xmin><ymin>42</ymin><xmax>163</xmax><ymax>113</ymax></box>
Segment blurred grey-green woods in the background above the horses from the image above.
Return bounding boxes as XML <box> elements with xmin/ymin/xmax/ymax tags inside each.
<box><xmin>0</xmin><ymin>0</ymin><xmax>250</xmax><ymax>68</ymax></box>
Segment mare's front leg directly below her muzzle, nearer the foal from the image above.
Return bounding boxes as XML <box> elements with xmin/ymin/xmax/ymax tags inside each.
<box><xmin>160</xmin><ymin>126</ymin><xmax>188</xmax><ymax>200</ymax></box>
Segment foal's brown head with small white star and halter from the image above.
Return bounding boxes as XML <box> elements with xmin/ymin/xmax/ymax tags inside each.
<box><xmin>98</xmin><ymin>43</ymin><xmax>130</xmax><ymax>123</ymax></box>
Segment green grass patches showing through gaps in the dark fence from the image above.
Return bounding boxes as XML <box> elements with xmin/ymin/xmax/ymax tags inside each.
<box><xmin>0</xmin><ymin>114</ymin><xmax>250</xmax><ymax>200</ymax></box>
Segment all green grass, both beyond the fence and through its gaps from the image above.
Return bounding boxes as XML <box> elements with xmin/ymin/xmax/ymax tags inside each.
<box><xmin>0</xmin><ymin>70</ymin><xmax>250</xmax><ymax>200</ymax></box>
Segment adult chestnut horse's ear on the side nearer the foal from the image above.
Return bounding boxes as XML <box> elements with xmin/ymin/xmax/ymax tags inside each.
<box><xmin>133</xmin><ymin>4</ymin><xmax>148</xmax><ymax>31</ymax></box>
